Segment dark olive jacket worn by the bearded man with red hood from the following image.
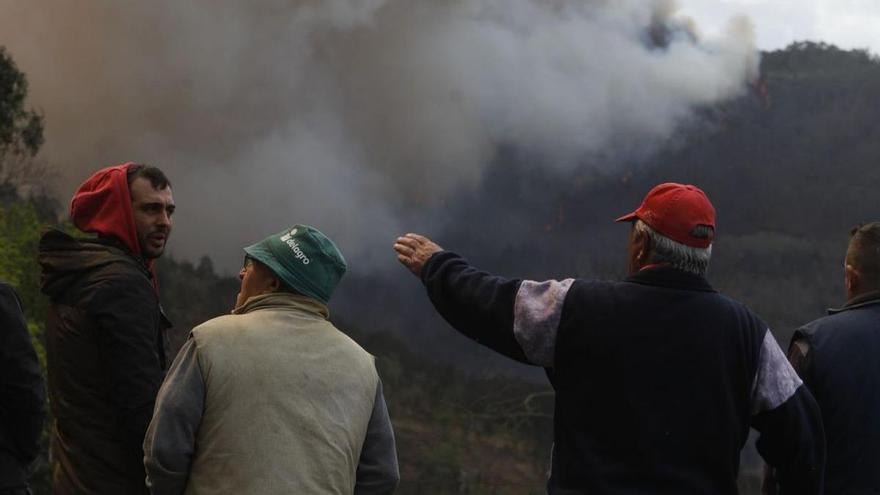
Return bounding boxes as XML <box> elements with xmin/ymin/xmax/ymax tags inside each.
<box><xmin>39</xmin><ymin>230</ymin><xmax>170</xmax><ymax>494</ymax></box>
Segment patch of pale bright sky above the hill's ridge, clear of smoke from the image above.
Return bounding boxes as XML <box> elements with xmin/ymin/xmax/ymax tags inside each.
<box><xmin>678</xmin><ymin>0</ymin><xmax>880</xmax><ymax>54</ymax></box>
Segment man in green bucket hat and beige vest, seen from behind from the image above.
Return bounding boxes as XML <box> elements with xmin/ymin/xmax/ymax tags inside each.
<box><xmin>144</xmin><ymin>225</ymin><xmax>399</xmax><ymax>495</ymax></box>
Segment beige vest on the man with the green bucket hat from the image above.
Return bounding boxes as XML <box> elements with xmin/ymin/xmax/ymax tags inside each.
<box><xmin>186</xmin><ymin>293</ymin><xmax>378</xmax><ymax>495</ymax></box>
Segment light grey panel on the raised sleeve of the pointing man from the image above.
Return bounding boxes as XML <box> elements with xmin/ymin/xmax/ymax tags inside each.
<box><xmin>513</xmin><ymin>278</ymin><xmax>574</xmax><ymax>368</ymax></box>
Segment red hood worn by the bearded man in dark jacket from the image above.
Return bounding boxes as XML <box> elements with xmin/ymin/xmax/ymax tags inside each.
<box><xmin>70</xmin><ymin>162</ymin><xmax>159</xmax><ymax>292</ymax></box>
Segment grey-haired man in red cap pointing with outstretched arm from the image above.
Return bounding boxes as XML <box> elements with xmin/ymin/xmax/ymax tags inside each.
<box><xmin>394</xmin><ymin>183</ymin><xmax>824</xmax><ymax>495</ymax></box>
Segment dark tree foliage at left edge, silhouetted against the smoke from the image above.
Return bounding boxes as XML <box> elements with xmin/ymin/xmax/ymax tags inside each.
<box><xmin>0</xmin><ymin>47</ymin><xmax>43</xmax><ymax>159</ymax></box>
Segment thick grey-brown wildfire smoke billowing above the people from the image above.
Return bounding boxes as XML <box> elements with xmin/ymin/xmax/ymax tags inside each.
<box><xmin>0</xmin><ymin>0</ymin><xmax>758</xmax><ymax>270</ymax></box>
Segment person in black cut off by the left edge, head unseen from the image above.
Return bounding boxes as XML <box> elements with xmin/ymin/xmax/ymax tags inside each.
<box><xmin>0</xmin><ymin>283</ymin><xmax>46</xmax><ymax>495</ymax></box>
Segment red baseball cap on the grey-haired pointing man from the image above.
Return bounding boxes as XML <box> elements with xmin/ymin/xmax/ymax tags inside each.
<box><xmin>616</xmin><ymin>182</ymin><xmax>715</xmax><ymax>249</ymax></box>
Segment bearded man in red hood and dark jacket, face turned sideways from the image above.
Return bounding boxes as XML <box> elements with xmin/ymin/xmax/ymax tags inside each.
<box><xmin>39</xmin><ymin>163</ymin><xmax>174</xmax><ymax>494</ymax></box>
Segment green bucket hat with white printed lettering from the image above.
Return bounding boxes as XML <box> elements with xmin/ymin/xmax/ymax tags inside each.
<box><xmin>244</xmin><ymin>224</ymin><xmax>347</xmax><ymax>304</ymax></box>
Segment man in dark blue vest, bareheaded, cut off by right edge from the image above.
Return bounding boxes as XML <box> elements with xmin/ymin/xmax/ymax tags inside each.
<box><xmin>789</xmin><ymin>222</ymin><xmax>880</xmax><ymax>495</ymax></box>
